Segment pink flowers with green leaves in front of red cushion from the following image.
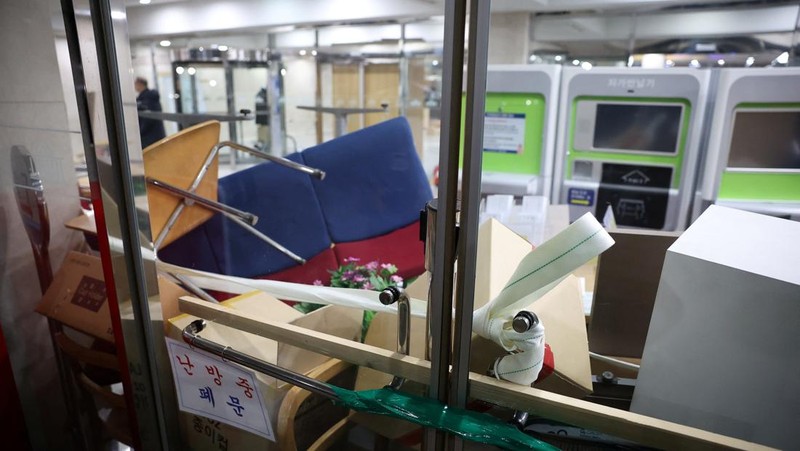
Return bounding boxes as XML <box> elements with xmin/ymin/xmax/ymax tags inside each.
<box><xmin>295</xmin><ymin>257</ymin><xmax>404</xmax><ymax>341</ymax></box>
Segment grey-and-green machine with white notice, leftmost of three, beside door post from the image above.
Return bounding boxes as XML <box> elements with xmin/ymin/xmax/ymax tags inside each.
<box><xmin>462</xmin><ymin>65</ymin><xmax>561</xmax><ymax>198</ymax></box>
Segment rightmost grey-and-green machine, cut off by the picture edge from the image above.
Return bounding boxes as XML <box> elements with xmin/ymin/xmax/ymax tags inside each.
<box><xmin>693</xmin><ymin>67</ymin><xmax>800</xmax><ymax>220</ymax></box>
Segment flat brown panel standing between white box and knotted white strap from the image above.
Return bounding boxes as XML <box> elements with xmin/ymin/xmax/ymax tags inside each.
<box><xmin>589</xmin><ymin>230</ymin><xmax>679</xmax><ymax>358</ymax></box>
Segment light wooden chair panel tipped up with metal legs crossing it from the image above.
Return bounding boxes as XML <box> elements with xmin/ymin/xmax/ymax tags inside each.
<box><xmin>144</xmin><ymin>121</ymin><xmax>220</xmax><ymax>246</ymax></box>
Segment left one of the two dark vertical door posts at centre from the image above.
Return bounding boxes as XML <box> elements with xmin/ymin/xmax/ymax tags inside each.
<box><xmin>424</xmin><ymin>0</ymin><xmax>467</xmax><ymax>450</ymax></box>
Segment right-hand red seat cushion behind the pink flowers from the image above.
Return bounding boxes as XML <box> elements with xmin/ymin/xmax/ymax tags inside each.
<box><xmin>333</xmin><ymin>221</ymin><xmax>425</xmax><ymax>279</ymax></box>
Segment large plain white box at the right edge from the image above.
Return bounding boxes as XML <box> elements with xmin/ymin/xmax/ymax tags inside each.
<box><xmin>631</xmin><ymin>206</ymin><xmax>800</xmax><ymax>449</ymax></box>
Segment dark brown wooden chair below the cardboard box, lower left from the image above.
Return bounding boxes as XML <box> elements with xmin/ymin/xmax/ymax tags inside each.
<box><xmin>54</xmin><ymin>330</ymin><xmax>133</xmax><ymax>449</ymax></box>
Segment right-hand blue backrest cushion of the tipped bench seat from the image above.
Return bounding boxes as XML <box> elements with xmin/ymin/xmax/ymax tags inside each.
<box><xmin>302</xmin><ymin>117</ymin><xmax>433</xmax><ymax>243</ymax></box>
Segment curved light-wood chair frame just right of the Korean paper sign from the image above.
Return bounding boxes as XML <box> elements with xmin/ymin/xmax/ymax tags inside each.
<box><xmin>277</xmin><ymin>359</ymin><xmax>356</xmax><ymax>451</ymax></box>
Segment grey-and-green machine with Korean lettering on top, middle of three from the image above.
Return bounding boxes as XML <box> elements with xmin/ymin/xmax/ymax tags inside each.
<box><xmin>553</xmin><ymin>68</ymin><xmax>710</xmax><ymax>230</ymax></box>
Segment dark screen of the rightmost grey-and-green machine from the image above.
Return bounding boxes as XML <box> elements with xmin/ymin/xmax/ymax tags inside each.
<box><xmin>728</xmin><ymin>111</ymin><xmax>800</xmax><ymax>170</ymax></box>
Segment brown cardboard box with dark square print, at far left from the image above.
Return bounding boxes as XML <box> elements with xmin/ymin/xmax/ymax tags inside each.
<box><xmin>36</xmin><ymin>252</ymin><xmax>189</xmax><ymax>343</ymax></box>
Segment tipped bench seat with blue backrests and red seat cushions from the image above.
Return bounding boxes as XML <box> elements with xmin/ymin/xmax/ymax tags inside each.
<box><xmin>157</xmin><ymin>118</ymin><xmax>432</xmax><ymax>283</ymax></box>
